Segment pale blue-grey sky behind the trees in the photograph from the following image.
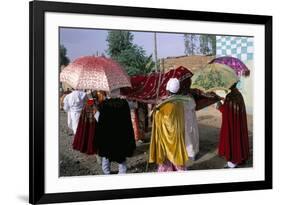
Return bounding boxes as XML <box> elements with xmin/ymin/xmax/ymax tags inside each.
<box><xmin>60</xmin><ymin>28</ymin><xmax>184</xmax><ymax>61</ymax></box>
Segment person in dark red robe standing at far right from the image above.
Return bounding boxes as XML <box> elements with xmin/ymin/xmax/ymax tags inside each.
<box><xmin>217</xmin><ymin>83</ymin><xmax>249</xmax><ymax>168</ymax></box>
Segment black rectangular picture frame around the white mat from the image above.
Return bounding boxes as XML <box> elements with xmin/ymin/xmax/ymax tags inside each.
<box><xmin>29</xmin><ymin>1</ymin><xmax>272</xmax><ymax>204</ymax></box>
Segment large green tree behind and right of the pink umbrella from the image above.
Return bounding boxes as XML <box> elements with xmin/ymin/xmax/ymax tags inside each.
<box><xmin>106</xmin><ymin>31</ymin><xmax>154</xmax><ymax>75</ymax></box>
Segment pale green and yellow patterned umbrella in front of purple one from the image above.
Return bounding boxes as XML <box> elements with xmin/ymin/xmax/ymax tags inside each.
<box><xmin>191</xmin><ymin>63</ymin><xmax>238</xmax><ymax>92</ymax></box>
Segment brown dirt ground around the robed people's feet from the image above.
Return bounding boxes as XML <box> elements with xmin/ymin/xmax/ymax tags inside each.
<box><xmin>59</xmin><ymin>106</ymin><xmax>253</xmax><ymax>176</ymax></box>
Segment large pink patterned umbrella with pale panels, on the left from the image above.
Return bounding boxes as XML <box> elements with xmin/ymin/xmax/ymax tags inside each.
<box><xmin>60</xmin><ymin>56</ymin><xmax>131</xmax><ymax>92</ymax></box>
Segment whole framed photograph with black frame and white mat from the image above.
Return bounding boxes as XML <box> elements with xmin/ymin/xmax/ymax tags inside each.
<box><xmin>29</xmin><ymin>1</ymin><xmax>272</xmax><ymax>204</ymax></box>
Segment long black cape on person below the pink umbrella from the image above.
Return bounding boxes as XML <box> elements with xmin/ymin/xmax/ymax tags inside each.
<box><xmin>96</xmin><ymin>99</ymin><xmax>136</xmax><ymax>163</ymax></box>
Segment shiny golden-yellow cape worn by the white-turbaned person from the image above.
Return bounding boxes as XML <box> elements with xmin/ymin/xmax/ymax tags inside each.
<box><xmin>149</xmin><ymin>101</ymin><xmax>188</xmax><ymax>166</ymax></box>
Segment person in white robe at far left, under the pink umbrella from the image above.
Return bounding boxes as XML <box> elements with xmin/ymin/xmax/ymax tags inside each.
<box><xmin>63</xmin><ymin>90</ymin><xmax>87</xmax><ymax>135</ymax></box>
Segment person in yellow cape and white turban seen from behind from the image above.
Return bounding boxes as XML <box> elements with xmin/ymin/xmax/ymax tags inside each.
<box><xmin>149</xmin><ymin>78</ymin><xmax>188</xmax><ymax>172</ymax></box>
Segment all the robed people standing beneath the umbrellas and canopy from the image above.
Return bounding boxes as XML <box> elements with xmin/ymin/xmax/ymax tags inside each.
<box><xmin>62</xmin><ymin>78</ymin><xmax>249</xmax><ymax>174</ymax></box>
